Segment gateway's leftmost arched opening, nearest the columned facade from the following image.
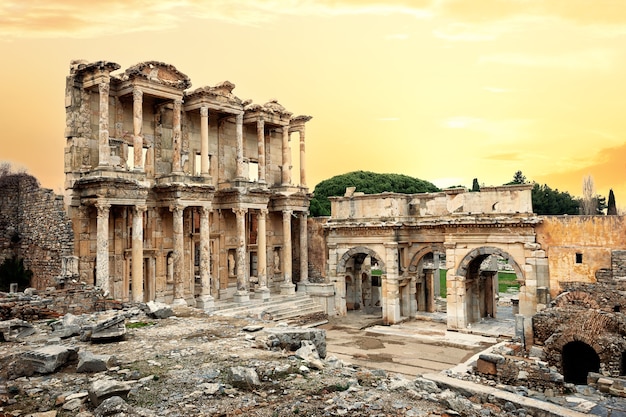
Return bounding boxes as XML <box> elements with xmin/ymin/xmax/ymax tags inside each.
<box><xmin>337</xmin><ymin>246</ymin><xmax>385</xmax><ymax>314</ymax></box>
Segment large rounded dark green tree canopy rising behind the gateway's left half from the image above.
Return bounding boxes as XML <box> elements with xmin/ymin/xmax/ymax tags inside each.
<box><xmin>310</xmin><ymin>171</ymin><xmax>440</xmax><ymax>216</ymax></box>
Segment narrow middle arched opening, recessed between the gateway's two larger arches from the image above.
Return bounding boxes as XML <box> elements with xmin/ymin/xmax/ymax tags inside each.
<box><xmin>409</xmin><ymin>245</ymin><xmax>446</xmax><ymax>313</ymax></box>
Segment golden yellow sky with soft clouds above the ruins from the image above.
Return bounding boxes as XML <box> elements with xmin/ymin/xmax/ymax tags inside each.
<box><xmin>0</xmin><ymin>0</ymin><xmax>626</xmax><ymax>207</ymax></box>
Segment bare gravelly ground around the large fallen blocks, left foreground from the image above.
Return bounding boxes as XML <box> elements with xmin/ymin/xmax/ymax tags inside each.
<box><xmin>0</xmin><ymin>309</ymin><xmax>466</xmax><ymax>417</ymax></box>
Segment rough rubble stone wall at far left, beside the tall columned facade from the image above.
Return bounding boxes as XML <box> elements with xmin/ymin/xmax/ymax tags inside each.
<box><xmin>0</xmin><ymin>174</ymin><xmax>74</xmax><ymax>288</ymax></box>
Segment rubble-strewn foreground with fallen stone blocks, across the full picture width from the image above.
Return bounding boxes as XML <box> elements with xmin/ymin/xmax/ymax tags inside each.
<box><xmin>0</xmin><ymin>292</ymin><xmax>626</xmax><ymax>417</ymax></box>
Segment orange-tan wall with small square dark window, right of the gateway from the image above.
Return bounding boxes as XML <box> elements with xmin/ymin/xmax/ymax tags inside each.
<box><xmin>535</xmin><ymin>216</ymin><xmax>626</xmax><ymax>298</ymax></box>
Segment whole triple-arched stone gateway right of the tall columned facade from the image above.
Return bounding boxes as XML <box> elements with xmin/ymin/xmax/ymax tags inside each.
<box><xmin>324</xmin><ymin>185</ymin><xmax>548</xmax><ymax>331</ymax></box>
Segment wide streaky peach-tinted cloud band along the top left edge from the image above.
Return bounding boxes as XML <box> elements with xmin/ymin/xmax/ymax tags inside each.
<box><xmin>0</xmin><ymin>0</ymin><xmax>432</xmax><ymax>40</ymax></box>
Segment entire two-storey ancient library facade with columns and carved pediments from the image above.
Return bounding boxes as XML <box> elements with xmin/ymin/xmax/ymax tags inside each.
<box><xmin>65</xmin><ymin>61</ymin><xmax>310</xmax><ymax>307</ymax></box>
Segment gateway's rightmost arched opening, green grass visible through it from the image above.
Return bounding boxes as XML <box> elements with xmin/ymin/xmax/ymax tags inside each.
<box><xmin>456</xmin><ymin>246</ymin><xmax>524</xmax><ymax>323</ymax></box>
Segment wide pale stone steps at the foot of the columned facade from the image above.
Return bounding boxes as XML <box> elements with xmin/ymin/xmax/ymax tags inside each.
<box><xmin>211</xmin><ymin>294</ymin><xmax>325</xmax><ymax>322</ymax></box>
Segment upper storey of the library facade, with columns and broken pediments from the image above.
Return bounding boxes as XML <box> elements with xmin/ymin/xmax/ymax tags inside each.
<box><xmin>65</xmin><ymin>61</ymin><xmax>311</xmax><ymax>188</ymax></box>
